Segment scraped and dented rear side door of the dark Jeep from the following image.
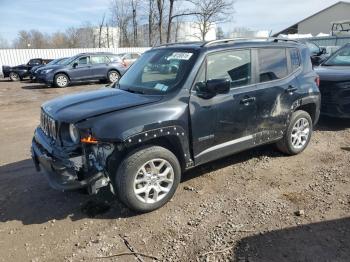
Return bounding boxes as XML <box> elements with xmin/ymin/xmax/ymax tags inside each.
<box><xmin>254</xmin><ymin>47</ymin><xmax>300</xmax><ymax>144</ymax></box>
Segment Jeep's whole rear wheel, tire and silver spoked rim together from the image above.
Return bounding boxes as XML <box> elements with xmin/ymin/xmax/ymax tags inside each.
<box><xmin>276</xmin><ymin>110</ymin><xmax>313</xmax><ymax>155</ymax></box>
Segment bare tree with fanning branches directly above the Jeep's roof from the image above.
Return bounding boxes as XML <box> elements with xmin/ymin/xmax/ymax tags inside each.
<box><xmin>188</xmin><ymin>0</ymin><xmax>234</xmax><ymax>41</ymax></box>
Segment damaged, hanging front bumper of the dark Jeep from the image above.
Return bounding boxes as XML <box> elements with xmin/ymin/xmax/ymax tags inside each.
<box><xmin>31</xmin><ymin>128</ymin><xmax>109</xmax><ymax>194</ymax></box>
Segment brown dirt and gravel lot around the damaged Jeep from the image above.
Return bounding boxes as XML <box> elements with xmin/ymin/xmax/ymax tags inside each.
<box><xmin>0</xmin><ymin>80</ymin><xmax>350</xmax><ymax>262</ymax></box>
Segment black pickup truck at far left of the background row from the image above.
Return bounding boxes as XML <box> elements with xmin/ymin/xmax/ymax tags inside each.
<box><xmin>2</xmin><ymin>58</ymin><xmax>52</xmax><ymax>81</ymax></box>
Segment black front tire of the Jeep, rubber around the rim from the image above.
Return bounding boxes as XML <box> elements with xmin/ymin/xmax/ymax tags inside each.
<box><xmin>114</xmin><ymin>146</ymin><xmax>181</xmax><ymax>213</ymax></box>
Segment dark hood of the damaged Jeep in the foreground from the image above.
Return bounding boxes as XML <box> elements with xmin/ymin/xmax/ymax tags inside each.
<box><xmin>42</xmin><ymin>88</ymin><xmax>162</xmax><ymax>123</ymax></box>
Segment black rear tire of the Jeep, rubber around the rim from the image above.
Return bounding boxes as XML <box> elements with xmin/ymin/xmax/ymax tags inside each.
<box><xmin>276</xmin><ymin>110</ymin><xmax>313</xmax><ymax>155</ymax></box>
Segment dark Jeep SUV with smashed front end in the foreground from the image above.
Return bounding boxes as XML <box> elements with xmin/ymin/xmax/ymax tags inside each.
<box><xmin>32</xmin><ymin>39</ymin><xmax>320</xmax><ymax>212</ymax></box>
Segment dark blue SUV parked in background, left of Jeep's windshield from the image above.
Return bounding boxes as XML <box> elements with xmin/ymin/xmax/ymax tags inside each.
<box><xmin>36</xmin><ymin>53</ymin><xmax>127</xmax><ymax>87</ymax></box>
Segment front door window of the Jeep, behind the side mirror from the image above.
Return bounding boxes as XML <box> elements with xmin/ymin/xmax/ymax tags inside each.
<box><xmin>207</xmin><ymin>50</ymin><xmax>251</xmax><ymax>88</ymax></box>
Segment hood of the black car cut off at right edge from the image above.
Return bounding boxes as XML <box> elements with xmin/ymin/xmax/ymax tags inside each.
<box><xmin>315</xmin><ymin>66</ymin><xmax>350</xmax><ymax>82</ymax></box>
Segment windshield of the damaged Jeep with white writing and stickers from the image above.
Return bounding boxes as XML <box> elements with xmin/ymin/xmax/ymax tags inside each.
<box><xmin>119</xmin><ymin>49</ymin><xmax>198</xmax><ymax>94</ymax></box>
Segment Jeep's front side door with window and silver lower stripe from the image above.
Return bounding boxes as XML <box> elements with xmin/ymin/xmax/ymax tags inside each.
<box><xmin>190</xmin><ymin>49</ymin><xmax>257</xmax><ymax>165</ymax></box>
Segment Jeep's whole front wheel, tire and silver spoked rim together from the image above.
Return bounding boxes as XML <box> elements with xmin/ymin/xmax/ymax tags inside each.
<box><xmin>114</xmin><ymin>146</ymin><xmax>181</xmax><ymax>212</ymax></box>
